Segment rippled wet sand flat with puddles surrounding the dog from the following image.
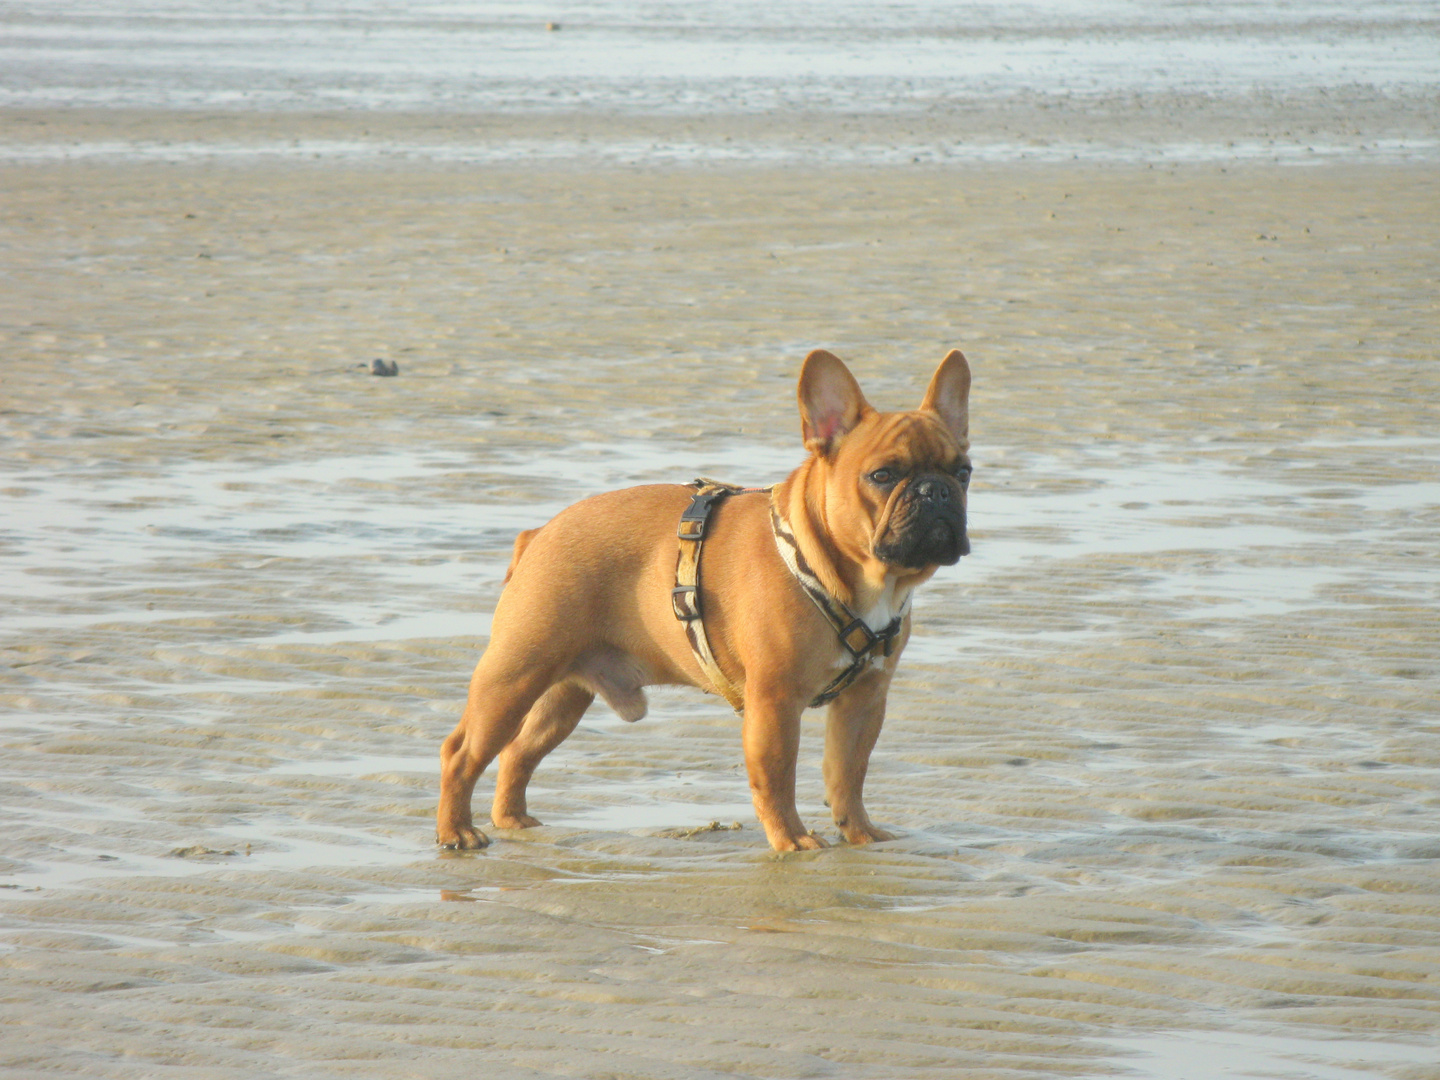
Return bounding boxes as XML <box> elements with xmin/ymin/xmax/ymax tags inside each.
<box><xmin>0</xmin><ymin>117</ymin><xmax>1440</xmax><ymax>1080</ymax></box>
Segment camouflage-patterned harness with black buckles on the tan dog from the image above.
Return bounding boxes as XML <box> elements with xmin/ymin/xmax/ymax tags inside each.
<box><xmin>670</xmin><ymin>477</ymin><xmax>910</xmax><ymax>713</ymax></box>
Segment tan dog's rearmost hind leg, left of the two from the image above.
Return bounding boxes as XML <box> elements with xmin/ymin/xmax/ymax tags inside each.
<box><xmin>435</xmin><ymin>659</ymin><xmax>559</xmax><ymax>848</ymax></box>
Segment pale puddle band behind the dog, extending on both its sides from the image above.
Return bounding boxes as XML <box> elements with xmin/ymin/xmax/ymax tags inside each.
<box><xmin>0</xmin><ymin>439</ymin><xmax>1440</xmax><ymax>650</ymax></box>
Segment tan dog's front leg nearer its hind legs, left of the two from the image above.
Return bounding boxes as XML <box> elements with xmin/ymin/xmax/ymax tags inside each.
<box><xmin>742</xmin><ymin>694</ymin><xmax>828</xmax><ymax>851</ymax></box>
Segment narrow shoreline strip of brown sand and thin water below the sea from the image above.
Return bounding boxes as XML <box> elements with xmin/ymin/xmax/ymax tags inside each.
<box><xmin>11</xmin><ymin>99</ymin><xmax>1440</xmax><ymax>168</ymax></box>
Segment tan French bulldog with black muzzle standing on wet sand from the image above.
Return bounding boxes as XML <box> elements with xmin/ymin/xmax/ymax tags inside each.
<box><xmin>436</xmin><ymin>350</ymin><xmax>971</xmax><ymax>851</ymax></box>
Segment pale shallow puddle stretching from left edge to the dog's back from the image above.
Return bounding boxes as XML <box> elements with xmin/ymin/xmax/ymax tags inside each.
<box><xmin>0</xmin><ymin>442</ymin><xmax>796</xmax><ymax>645</ymax></box>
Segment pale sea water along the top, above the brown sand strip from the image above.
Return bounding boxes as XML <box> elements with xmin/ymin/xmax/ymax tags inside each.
<box><xmin>0</xmin><ymin>0</ymin><xmax>1436</xmax><ymax>112</ymax></box>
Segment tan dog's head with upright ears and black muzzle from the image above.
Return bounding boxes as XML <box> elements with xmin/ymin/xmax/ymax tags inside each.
<box><xmin>799</xmin><ymin>350</ymin><xmax>971</xmax><ymax>577</ymax></box>
